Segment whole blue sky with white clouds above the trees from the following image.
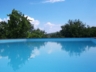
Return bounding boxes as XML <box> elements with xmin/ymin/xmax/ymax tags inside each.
<box><xmin>0</xmin><ymin>0</ymin><xmax>96</xmax><ymax>33</ymax></box>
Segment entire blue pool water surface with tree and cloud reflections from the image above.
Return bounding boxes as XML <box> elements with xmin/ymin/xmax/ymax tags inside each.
<box><xmin>0</xmin><ymin>39</ymin><xmax>96</xmax><ymax>72</ymax></box>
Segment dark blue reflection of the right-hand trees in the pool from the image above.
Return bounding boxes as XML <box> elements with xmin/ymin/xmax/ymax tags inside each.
<box><xmin>58</xmin><ymin>41</ymin><xmax>96</xmax><ymax>56</ymax></box>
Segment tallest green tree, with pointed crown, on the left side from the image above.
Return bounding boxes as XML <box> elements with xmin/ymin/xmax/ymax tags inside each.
<box><xmin>8</xmin><ymin>9</ymin><xmax>33</xmax><ymax>38</ymax></box>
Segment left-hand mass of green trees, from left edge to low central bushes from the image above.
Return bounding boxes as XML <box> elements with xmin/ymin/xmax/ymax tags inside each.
<box><xmin>0</xmin><ymin>9</ymin><xmax>45</xmax><ymax>39</ymax></box>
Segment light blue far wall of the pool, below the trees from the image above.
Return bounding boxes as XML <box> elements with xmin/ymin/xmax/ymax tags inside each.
<box><xmin>0</xmin><ymin>38</ymin><xmax>96</xmax><ymax>44</ymax></box>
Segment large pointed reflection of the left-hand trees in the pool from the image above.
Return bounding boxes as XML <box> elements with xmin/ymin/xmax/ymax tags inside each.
<box><xmin>0</xmin><ymin>42</ymin><xmax>45</xmax><ymax>70</ymax></box>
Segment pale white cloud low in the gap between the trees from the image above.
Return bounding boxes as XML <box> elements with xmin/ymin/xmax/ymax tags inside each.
<box><xmin>44</xmin><ymin>22</ymin><xmax>61</xmax><ymax>33</ymax></box>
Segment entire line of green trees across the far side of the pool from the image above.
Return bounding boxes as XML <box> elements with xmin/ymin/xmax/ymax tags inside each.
<box><xmin>0</xmin><ymin>9</ymin><xmax>96</xmax><ymax>39</ymax></box>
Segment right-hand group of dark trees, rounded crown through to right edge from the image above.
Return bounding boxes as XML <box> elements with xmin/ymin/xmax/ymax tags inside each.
<box><xmin>60</xmin><ymin>20</ymin><xmax>96</xmax><ymax>37</ymax></box>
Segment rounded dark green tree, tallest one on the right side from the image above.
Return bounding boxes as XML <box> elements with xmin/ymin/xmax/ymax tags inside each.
<box><xmin>60</xmin><ymin>20</ymin><xmax>86</xmax><ymax>37</ymax></box>
